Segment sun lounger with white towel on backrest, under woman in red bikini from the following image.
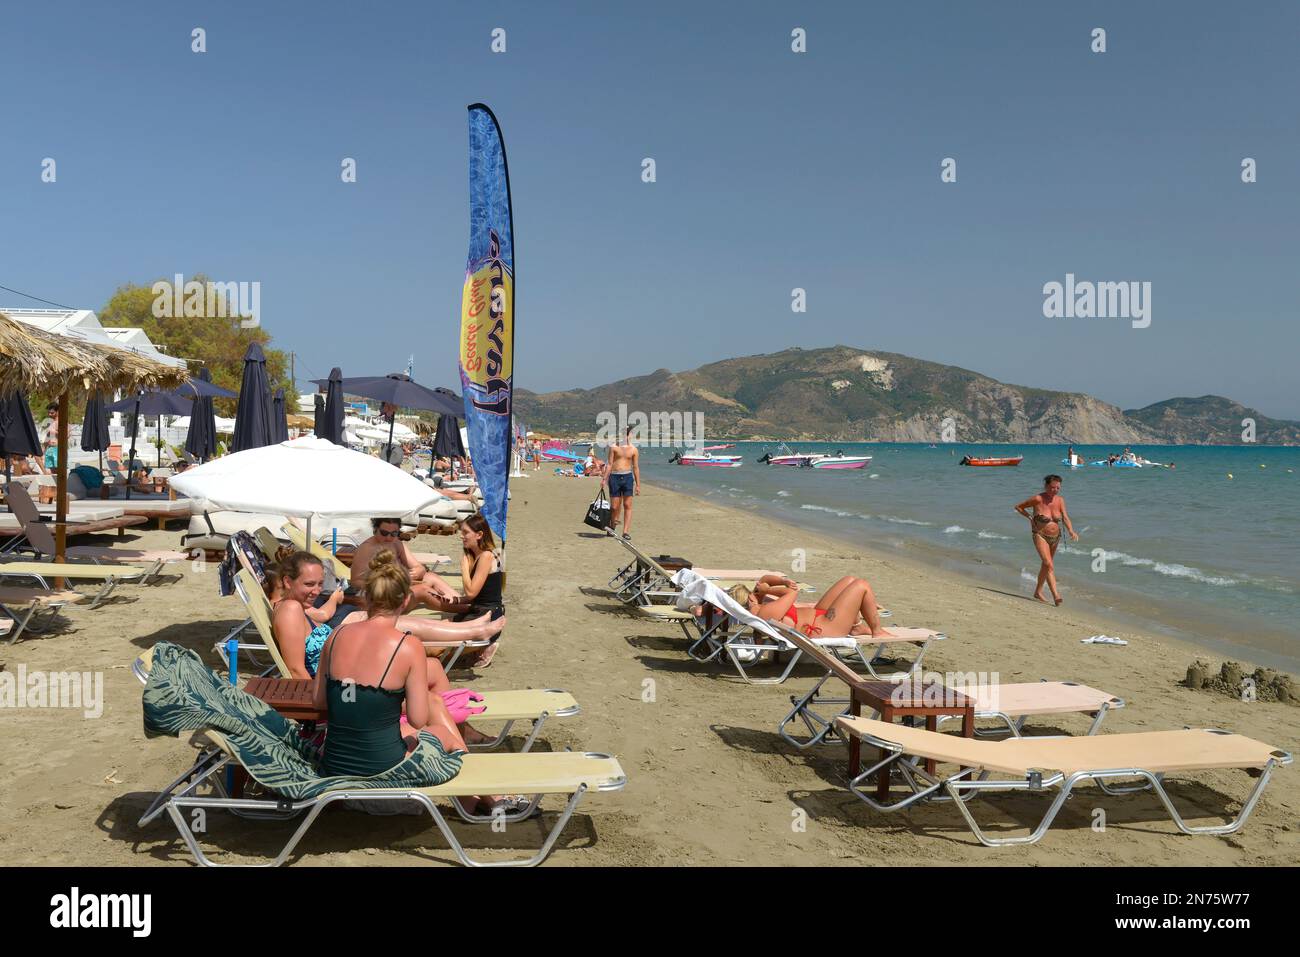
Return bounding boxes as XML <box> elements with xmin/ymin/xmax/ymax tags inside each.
<box><xmin>672</xmin><ymin>568</ymin><xmax>948</xmax><ymax>684</ymax></box>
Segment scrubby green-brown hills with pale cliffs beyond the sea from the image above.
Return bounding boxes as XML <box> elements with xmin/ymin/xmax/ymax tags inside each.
<box><xmin>516</xmin><ymin>346</ymin><xmax>1300</xmax><ymax>445</ymax></box>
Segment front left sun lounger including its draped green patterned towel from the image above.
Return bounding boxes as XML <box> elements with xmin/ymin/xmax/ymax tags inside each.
<box><xmin>139</xmin><ymin>642</ymin><xmax>627</xmax><ymax>867</ymax></box>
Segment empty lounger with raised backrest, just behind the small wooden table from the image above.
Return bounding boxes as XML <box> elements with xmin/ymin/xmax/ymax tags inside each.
<box><xmin>776</xmin><ymin>624</ymin><xmax>1125</xmax><ymax>748</ymax></box>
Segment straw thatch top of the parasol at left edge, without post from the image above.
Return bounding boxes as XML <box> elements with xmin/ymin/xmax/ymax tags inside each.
<box><xmin>0</xmin><ymin>313</ymin><xmax>189</xmax><ymax>395</ymax></box>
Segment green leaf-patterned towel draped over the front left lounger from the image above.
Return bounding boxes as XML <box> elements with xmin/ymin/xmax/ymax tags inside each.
<box><xmin>144</xmin><ymin>641</ymin><xmax>462</xmax><ymax>800</ymax></box>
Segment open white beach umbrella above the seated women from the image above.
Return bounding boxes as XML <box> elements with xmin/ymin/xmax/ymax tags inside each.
<box><xmin>172</xmin><ymin>437</ymin><xmax>442</xmax><ymax>538</ymax></box>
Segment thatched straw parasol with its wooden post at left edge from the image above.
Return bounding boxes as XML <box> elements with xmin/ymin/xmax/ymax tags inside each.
<box><xmin>0</xmin><ymin>313</ymin><xmax>190</xmax><ymax>562</ymax></box>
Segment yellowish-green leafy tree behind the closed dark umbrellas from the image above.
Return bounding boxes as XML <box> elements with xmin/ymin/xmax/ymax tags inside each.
<box><xmin>99</xmin><ymin>273</ymin><xmax>298</xmax><ymax>417</ymax></box>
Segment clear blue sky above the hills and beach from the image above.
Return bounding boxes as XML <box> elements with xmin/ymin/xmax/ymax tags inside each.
<box><xmin>0</xmin><ymin>1</ymin><xmax>1300</xmax><ymax>417</ymax></box>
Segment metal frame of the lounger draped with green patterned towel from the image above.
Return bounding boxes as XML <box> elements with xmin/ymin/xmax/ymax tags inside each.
<box><xmin>139</xmin><ymin>731</ymin><xmax>627</xmax><ymax>867</ymax></box>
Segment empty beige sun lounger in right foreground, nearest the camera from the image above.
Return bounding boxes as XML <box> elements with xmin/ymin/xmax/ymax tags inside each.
<box><xmin>836</xmin><ymin>716</ymin><xmax>1291</xmax><ymax>848</ymax></box>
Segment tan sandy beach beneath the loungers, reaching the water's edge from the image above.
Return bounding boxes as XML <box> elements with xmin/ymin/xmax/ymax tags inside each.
<box><xmin>0</xmin><ymin>471</ymin><xmax>1300</xmax><ymax>866</ymax></box>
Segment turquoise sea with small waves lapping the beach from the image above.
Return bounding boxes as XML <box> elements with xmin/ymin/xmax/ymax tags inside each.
<box><xmin>642</xmin><ymin>442</ymin><xmax>1300</xmax><ymax>672</ymax></box>
